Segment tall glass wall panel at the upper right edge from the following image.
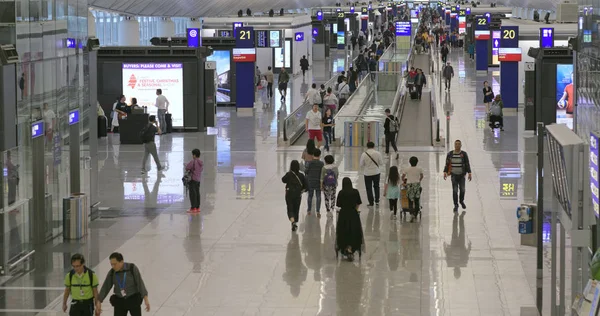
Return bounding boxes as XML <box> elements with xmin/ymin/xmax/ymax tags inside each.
<box><xmin>576</xmin><ymin>4</ymin><xmax>600</xmax><ymax>140</ymax></box>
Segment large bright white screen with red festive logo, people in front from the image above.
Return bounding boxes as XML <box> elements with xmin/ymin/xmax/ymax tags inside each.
<box><xmin>122</xmin><ymin>63</ymin><xmax>183</xmax><ymax>127</ymax></box>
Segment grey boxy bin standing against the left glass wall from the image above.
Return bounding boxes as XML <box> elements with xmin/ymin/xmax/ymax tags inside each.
<box><xmin>63</xmin><ymin>193</ymin><xmax>88</xmax><ymax>239</ymax></box>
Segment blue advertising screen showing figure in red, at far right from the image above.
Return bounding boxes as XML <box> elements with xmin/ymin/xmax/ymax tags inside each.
<box><xmin>556</xmin><ymin>64</ymin><xmax>574</xmax><ymax>129</ymax></box>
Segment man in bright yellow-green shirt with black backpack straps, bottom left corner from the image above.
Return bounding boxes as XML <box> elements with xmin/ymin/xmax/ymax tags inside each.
<box><xmin>63</xmin><ymin>253</ymin><xmax>101</xmax><ymax>316</ymax></box>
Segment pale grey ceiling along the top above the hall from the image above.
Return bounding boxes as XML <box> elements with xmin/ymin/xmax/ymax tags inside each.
<box><xmin>88</xmin><ymin>0</ymin><xmax>562</xmax><ymax>17</ymax></box>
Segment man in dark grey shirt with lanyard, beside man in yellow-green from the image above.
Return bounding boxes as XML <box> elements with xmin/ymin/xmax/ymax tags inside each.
<box><xmin>97</xmin><ymin>252</ymin><xmax>150</xmax><ymax>316</ymax></box>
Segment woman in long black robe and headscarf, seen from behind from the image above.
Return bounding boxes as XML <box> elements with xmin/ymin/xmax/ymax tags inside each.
<box><xmin>335</xmin><ymin>177</ymin><xmax>365</xmax><ymax>261</ymax></box>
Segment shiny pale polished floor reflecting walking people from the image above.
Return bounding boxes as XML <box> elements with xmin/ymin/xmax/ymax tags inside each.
<box><xmin>0</xmin><ymin>52</ymin><xmax>535</xmax><ymax>316</ymax></box>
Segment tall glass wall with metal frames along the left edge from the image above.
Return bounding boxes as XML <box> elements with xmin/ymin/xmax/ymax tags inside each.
<box><xmin>0</xmin><ymin>0</ymin><xmax>90</xmax><ymax>262</ymax></box>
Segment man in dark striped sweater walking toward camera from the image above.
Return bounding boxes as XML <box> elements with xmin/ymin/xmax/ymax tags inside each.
<box><xmin>444</xmin><ymin>139</ymin><xmax>472</xmax><ymax>213</ymax></box>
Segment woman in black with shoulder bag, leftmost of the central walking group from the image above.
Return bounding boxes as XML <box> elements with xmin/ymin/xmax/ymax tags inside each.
<box><xmin>281</xmin><ymin>160</ymin><xmax>308</xmax><ymax>232</ymax></box>
